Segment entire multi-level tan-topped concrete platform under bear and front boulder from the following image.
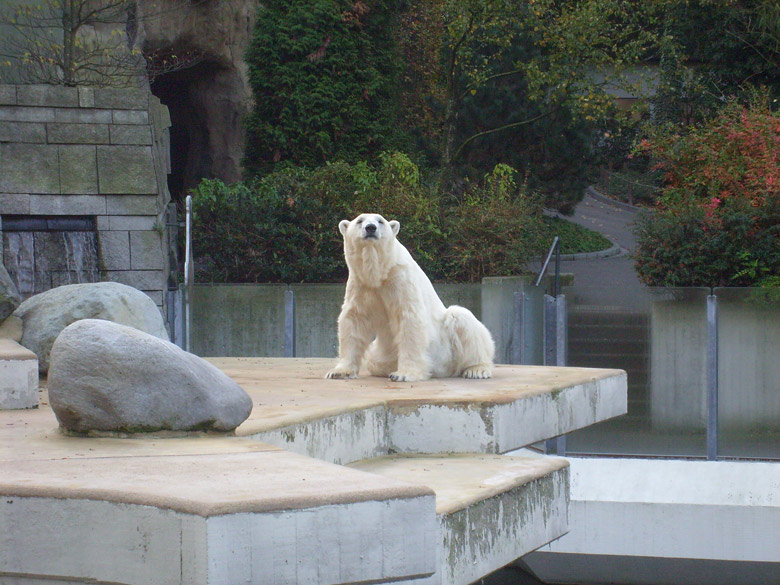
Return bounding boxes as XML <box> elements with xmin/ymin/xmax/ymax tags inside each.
<box><xmin>0</xmin><ymin>358</ymin><xmax>625</xmax><ymax>585</ymax></box>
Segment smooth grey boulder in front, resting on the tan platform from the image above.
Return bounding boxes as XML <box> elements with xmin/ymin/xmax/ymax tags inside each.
<box><xmin>49</xmin><ymin>319</ymin><xmax>252</xmax><ymax>433</ymax></box>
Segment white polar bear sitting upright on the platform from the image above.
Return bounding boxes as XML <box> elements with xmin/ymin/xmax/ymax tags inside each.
<box><xmin>326</xmin><ymin>213</ymin><xmax>495</xmax><ymax>382</ymax></box>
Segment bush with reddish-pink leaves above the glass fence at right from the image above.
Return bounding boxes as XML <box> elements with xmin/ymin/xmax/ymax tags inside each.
<box><xmin>635</xmin><ymin>101</ymin><xmax>780</xmax><ymax>286</ymax></box>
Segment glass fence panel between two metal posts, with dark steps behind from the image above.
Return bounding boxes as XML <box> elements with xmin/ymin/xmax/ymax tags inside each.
<box><xmin>564</xmin><ymin>286</ymin><xmax>710</xmax><ymax>457</ymax></box>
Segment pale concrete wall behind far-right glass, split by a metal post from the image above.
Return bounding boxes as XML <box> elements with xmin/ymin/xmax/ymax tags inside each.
<box><xmin>651</xmin><ymin>288</ymin><xmax>780</xmax><ymax>433</ymax></box>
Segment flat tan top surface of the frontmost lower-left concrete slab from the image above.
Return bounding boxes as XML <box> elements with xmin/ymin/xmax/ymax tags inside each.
<box><xmin>0</xmin><ymin>450</ymin><xmax>433</xmax><ymax>518</ymax></box>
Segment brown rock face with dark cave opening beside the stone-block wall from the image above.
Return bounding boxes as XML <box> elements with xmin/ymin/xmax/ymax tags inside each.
<box><xmin>136</xmin><ymin>0</ymin><xmax>260</xmax><ymax>196</ymax></box>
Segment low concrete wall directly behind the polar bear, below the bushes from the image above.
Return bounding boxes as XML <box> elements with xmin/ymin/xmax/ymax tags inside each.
<box><xmin>190</xmin><ymin>277</ymin><xmax>543</xmax><ymax>364</ymax></box>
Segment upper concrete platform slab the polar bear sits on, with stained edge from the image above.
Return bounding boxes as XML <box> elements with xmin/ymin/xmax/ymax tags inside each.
<box><xmin>218</xmin><ymin>358</ymin><xmax>626</xmax><ymax>464</ymax></box>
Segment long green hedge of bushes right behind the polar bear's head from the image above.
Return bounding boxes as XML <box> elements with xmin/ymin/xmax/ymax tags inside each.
<box><xmin>193</xmin><ymin>153</ymin><xmax>549</xmax><ymax>282</ymax></box>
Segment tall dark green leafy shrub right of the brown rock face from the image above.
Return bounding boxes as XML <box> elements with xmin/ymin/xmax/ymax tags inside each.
<box><xmin>244</xmin><ymin>0</ymin><xmax>398</xmax><ymax>176</ymax></box>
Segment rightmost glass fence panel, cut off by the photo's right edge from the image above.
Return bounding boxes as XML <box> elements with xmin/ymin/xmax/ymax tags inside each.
<box><xmin>715</xmin><ymin>288</ymin><xmax>780</xmax><ymax>459</ymax></box>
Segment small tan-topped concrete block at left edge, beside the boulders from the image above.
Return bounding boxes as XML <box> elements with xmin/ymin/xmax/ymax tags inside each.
<box><xmin>0</xmin><ymin>338</ymin><xmax>38</xmax><ymax>410</ymax></box>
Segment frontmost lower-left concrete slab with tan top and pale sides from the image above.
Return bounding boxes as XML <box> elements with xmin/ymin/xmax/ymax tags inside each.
<box><xmin>0</xmin><ymin>436</ymin><xmax>438</xmax><ymax>585</ymax></box>
